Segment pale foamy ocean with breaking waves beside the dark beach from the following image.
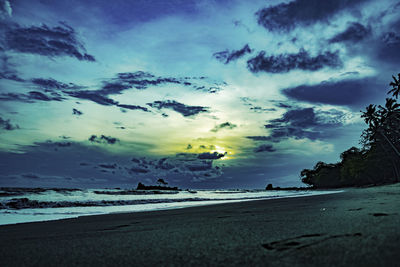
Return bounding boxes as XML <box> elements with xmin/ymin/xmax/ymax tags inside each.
<box><xmin>0</xmin><ymin>188</ymin><xmax>341</xmax><ymax>225</ymax></box>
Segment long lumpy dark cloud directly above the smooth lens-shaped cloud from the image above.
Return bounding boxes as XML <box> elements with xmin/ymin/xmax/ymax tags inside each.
<box><xmin>247</xmin><ymin>49</ymin><xmax>342</xmax><ymax>73</ymax></box>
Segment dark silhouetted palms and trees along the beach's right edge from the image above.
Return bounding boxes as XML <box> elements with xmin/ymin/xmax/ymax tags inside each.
<box><xmin>300</xmin><ymin>73</ymin><xmax>400</xmax><ymax>188</ymax></box>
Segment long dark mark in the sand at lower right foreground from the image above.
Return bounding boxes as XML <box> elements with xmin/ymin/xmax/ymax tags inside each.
<box><xmin>262</xmin><ymin>233</ymin><xmax>362</xmax><ymax>251</ymax></box>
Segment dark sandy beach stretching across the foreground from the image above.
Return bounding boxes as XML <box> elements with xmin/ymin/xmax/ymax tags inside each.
<box><xmin>0</xmin><ymin>184</ymin><xmax>400</xmax><ymax>266</ymax></box>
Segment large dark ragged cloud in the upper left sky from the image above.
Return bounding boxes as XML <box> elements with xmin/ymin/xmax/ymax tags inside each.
<box><xmin>5</xmin><ymin>23</ymin><xmax>95</xmax><ymax>61</ymax></box>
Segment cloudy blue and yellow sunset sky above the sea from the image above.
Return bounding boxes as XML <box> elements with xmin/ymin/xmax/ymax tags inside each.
<box><xmin>0</xmin><ymin>0</ymin><xmax>400</xmax><ymax>188</ymax></box>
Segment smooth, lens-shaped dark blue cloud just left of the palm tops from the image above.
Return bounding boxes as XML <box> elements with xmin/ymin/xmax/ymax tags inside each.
<box><xmin>282</xmin><ymin>77</ymin><xmax>387</xmax><ymax>108</ymax></box>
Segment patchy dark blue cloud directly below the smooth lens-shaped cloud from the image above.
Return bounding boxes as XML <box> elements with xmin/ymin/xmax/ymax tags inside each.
<box><xmin>264</xmin><ymin>108</ymin><xmax>345</xmax><ymax>142</ymax></box>
